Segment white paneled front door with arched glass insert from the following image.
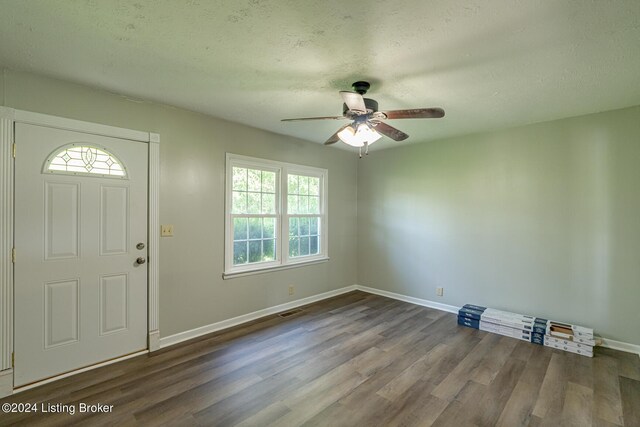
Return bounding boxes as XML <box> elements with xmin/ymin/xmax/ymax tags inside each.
<box><xmin>14</xmin><ymin>123</ymin><xmax>148</xmax><ymax>387</ymax></box>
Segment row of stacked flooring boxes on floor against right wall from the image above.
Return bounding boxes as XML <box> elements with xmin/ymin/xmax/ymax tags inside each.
<box><xmin>458</xmin><ymin>304</ymin><xmax>595</xmax><ymax>357</ymax></box>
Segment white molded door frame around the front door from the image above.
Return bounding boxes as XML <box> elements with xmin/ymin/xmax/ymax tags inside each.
<box><xmin>0</xmin><ymin>107</ymin><xmax>160</xmax><ymax>398</ymax></box>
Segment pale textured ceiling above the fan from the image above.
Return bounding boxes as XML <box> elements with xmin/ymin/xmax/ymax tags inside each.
<box><xmin>0</xmin><ymin>0</ymin><xmax>640</xmax><ymax>148</ymax></box>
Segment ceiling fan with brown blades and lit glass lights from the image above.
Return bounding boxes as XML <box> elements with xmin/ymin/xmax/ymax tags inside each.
<box><xmin>282</xmin><ymin>81</ymin><xmax>444</xmax><ymax>157</ymax></box>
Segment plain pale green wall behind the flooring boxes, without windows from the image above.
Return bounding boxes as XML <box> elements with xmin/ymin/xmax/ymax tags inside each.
<box><xmin>358</xmin><ymin>107</ymin><xmax>640</xmax><ymax>344</ymax></box>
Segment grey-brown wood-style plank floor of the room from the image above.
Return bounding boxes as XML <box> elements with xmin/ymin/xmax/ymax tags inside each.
<box><xmin>0</xmin><ymin>292</ymin><xmax>640</xmax><ymax>427</ymax></box>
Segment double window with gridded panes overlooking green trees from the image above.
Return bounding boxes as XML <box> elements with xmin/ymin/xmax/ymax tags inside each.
<box><xmin>225</xmin><ymin>154</ymin><xmax>327</xmax><ymax>275</ymax></box>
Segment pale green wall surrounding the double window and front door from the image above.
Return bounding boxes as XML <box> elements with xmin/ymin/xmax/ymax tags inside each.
<box><xmin>0</xmin><ymin>70</ymin><xmax>357</xmax><ymax>337</ymax></box>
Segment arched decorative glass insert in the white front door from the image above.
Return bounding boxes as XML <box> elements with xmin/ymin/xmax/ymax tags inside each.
<box><xmin>45</xmin><ymin>144</ymin><xmax>127</xmax><ymax>178</ymax></box>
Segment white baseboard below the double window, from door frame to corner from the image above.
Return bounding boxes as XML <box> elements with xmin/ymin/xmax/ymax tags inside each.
<box><xmin>160</xmin><ymin>285</ymin><xmax>357</xmax><ymax>348</ymax></box>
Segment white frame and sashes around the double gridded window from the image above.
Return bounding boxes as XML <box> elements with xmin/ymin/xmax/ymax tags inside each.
<box><xmin>222</xmin><ymin>153</ymin><xmax>329</xmax><ymax>279</ymax></box>
